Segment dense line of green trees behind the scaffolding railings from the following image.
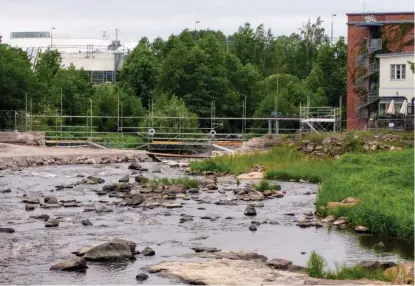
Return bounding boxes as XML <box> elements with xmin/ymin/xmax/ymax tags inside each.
<box><xmin>0</xmin><ymin>18</ymin><xmax>347</xmax><ymax>134</ymax></box>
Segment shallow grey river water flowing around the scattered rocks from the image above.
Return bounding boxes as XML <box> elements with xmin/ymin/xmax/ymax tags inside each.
<box><xmin>0</xmin><ymin>163</ymin><xmax>413</xmax><ymax>284</ymax></box>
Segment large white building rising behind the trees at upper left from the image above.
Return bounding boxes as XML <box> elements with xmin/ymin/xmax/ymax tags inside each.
<box><xmin>8</xmin><ymin>32</ymin><xmax>125</xmax><ymax>84</ymax></box>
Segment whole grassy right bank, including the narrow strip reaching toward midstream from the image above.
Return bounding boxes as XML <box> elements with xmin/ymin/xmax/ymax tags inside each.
<box><xmin>191</xmin><ymin>146</ymin><xmax>414</xmax><ymax>243</ymax></box>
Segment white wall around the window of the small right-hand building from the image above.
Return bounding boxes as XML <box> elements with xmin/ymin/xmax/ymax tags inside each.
<box><xmin>379</xmin><ymin>54</ymin><xmax>414</xmax><ymax>102</ymax></box>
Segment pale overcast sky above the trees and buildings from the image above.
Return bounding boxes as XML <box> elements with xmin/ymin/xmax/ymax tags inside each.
<box><xmin>0</xmin><ymin>0</ymin><xmax>414</xmax><ymax>43</ymax></box>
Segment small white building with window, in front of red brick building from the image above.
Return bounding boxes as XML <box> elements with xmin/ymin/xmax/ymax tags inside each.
<box><xmin>377</xmin><ymin>52</ymin><xmax>414</xmax><ymax>115</ymax></box>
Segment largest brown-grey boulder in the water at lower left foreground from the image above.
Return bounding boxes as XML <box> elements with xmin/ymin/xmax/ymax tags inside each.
<box><xmin>83</xmin><ymin>240</ymin><xmax>135</xmax><ymax>261</ymax></box>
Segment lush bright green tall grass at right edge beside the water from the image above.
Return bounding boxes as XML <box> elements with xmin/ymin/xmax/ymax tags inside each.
<box><xmin>316</xmin><ymin>149</ymin><xmax>414</xmax><ymax>243</ymax></box>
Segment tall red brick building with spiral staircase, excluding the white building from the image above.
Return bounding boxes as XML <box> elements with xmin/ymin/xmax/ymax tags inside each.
<box><xmin>347</xmin><ymin>12</ymin><xmax>414</xmax><ymax>130</ymax></box>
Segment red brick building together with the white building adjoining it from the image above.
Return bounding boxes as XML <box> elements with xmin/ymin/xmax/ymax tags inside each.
<box><xmin>347</xmin><ymin>12</ymin><xmax>414</xmax><ymax>130</ymax></box>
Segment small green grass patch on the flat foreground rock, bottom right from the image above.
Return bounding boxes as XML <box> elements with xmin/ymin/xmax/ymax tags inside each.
<box><xmin>307</xmin><ymin>251</ymin><xmax>391</xmax><ymax>281</ymax></box>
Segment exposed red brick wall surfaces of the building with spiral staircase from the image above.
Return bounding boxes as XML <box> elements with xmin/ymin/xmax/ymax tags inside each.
<box><xmin>347</xmin><ymin>14</ymin><xmax>414</xmax><ymax>130</ymax></box>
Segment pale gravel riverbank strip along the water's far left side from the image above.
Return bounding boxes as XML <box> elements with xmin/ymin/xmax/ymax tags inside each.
<box><xmin>0</xmin><ymin>143</ymin><xmax>151</xmax><ymax>170</ymax></box>
